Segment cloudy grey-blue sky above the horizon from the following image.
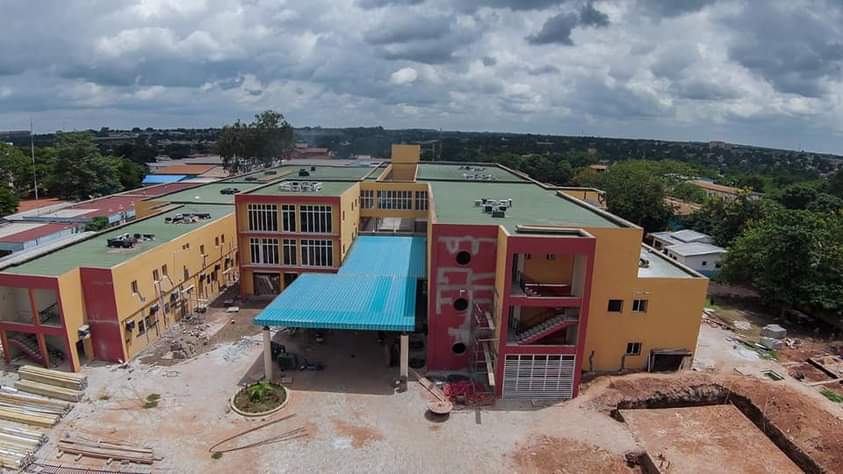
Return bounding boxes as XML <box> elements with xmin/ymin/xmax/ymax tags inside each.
<box><xmin>0</xmin><ymin>0</ymin><xmax>843</xmax><ymax>154</ymax></box>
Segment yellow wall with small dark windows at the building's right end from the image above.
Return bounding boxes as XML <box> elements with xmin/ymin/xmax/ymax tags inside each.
<box><xmin>583</xmin><ymin>228</ymin><xmax>708</xmax><ymax>371</ymax></box>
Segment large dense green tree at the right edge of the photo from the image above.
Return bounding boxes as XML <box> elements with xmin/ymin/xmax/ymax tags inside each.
<box><xmin>721</xmin><ymin>209</ymin><xmax>843</xmax><ymax>312</ymax></box>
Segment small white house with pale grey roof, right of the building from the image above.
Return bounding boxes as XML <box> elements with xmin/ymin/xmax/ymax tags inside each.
<box><xmin>648</xmin><ymin>229</ymin><xmax>726</xmax><ymax>276</ymax></box>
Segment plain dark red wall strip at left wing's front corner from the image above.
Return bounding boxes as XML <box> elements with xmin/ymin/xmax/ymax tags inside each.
<box><xmin>80</xmin><ymin>268</ymin><xmax>127</xmax><ymax>362</ymax></box>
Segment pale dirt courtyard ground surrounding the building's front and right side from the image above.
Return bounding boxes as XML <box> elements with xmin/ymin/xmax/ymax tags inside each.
<box><xmin>9</xmin><ymin>286</ymin><xmax>843</xmax><ymax>473</ymax></box>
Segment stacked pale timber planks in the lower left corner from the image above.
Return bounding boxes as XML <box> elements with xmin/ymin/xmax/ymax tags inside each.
<box><xmin>0</xmin><ymin>366</ymin><xmax>88</xmax><ymax>469</ymax></box>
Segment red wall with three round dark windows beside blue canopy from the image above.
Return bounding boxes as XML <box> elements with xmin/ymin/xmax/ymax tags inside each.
<box><xmin>427</xmin><ymin>224</ymin><xmax>498</xmax><ymax>370</ymax></box>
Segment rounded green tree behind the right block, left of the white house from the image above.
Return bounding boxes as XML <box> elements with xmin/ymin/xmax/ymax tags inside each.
<box><xmin>600</xmin><ymin>160</ymin><xmax>673</xmax><ymax>232</ymax></box>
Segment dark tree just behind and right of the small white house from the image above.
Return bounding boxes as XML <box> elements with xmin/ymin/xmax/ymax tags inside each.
<box><xmin>687</xmin><ymin>192</ymin><xmax>776</xmax><ymax>247</ymax></box>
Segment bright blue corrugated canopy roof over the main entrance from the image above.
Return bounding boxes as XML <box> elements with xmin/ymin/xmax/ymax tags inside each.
<box><xmin>254</xmin><ymin>236</ymin><xmax>426</xmax><ymax>331</ymax></box>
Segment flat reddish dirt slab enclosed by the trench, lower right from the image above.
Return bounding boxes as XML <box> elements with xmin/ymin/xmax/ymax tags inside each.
<box><xmin>621</xmin><ymin>405</ymin><xmax>802</xmax><ymax>474</ymax></box>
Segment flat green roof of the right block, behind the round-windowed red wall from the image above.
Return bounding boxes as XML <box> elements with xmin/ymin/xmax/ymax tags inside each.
<box><xmin>430</xmin><ymin>181</ymin><xmax>620</xmax><ymax>233</ymax></box>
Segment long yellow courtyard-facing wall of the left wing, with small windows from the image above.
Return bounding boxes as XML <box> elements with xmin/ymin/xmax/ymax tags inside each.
<box><xmin>112</xmin><ymin>212</ymin><xmax>237</xmax><ymax>358</ymax></box>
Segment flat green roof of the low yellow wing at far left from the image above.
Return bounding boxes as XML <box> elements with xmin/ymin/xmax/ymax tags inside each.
<box><xmin>3</xmin><ymin>204</ymin><xmax>234</xmax><ymax>276</ymax></box>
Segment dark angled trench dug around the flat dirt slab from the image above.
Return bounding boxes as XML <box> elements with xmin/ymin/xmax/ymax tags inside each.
<box><xmin>610</xmin><ymin>383</ymin><xmax>826</xmax><ymax>473</ymax></box>
